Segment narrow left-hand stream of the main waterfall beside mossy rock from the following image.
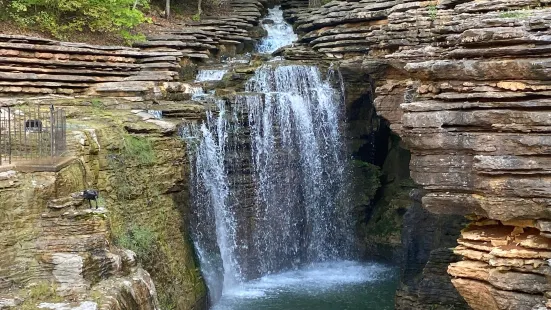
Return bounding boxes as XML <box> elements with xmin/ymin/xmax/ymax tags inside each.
<box><xmin>181</xmin><ymin>100</ymin><xmax>242</xmax><ymax>299</ymax></box>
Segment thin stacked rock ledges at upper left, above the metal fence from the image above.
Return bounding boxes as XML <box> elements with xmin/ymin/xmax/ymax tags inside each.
<box><xmin>0</xmin><ymin>0</ymin><xmax>267</xmax><ymax>98</ymax></box>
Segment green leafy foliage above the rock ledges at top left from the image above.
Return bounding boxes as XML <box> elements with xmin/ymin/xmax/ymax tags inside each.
<box><xmin>5</xmin><ymin>0</ymin><xmax>149</xmax><ymax>39</ymax></box>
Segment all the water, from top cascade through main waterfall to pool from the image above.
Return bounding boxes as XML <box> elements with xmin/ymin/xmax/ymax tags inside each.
<box><xmin>182</xmin><ymin>7</ymin><xmax>396</xmax><ymax>310</ymax></box>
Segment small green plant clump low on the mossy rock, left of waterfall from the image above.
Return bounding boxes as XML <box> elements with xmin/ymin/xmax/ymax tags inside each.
<box><xmin>115</xmin><ymin>226</ymin><xmax>157</xmax><ymax>261</ymax></box>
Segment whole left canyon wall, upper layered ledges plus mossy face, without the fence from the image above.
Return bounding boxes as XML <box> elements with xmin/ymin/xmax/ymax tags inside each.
<box><xmin>0</xmin><ymin>0</ymin><xmax>266</xmax><ymax>310</ymax></box>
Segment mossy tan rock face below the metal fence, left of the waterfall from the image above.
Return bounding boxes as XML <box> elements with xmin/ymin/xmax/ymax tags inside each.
<box><xmin>0</xmin><ymin>105</ymin><xmax>206</xmax><ymax>310</ymax></box>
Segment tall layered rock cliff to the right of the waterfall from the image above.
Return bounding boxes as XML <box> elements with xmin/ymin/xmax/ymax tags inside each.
<box><xmin>283</xmin><ymin>0</ymin><xmax>551</xmax><ymax>309</ymax></box>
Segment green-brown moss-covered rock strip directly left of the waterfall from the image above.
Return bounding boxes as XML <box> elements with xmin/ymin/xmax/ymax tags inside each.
<box><xmin>86</xmin><ymin>116</ymin><xmax>206</xmax><ymax>309</ymax></box>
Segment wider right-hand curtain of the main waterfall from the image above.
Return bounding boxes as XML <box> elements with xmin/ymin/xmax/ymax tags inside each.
<box><xmin>243</xmin><ymin>65</ymin><xmax>351</xmax><ymax>274</ymax></box>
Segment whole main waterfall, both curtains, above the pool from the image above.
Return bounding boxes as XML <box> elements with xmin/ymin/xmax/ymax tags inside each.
<box><xmin>184</xmin><ymin>63</ymin><xmax>353</xmax><ymax>300</ymax></box>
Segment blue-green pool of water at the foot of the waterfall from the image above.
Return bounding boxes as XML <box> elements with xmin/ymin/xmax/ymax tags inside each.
<box><xmin>213</xmin><ymin>261</ymin><xmax>398</xmax><ymax>310</ymax></box>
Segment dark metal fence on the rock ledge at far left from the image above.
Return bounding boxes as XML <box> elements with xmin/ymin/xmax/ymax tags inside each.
<box><xmin>0</xmin><ymin>105</ymin><xmax>67</xmax><ymax>165</ymax></box>
